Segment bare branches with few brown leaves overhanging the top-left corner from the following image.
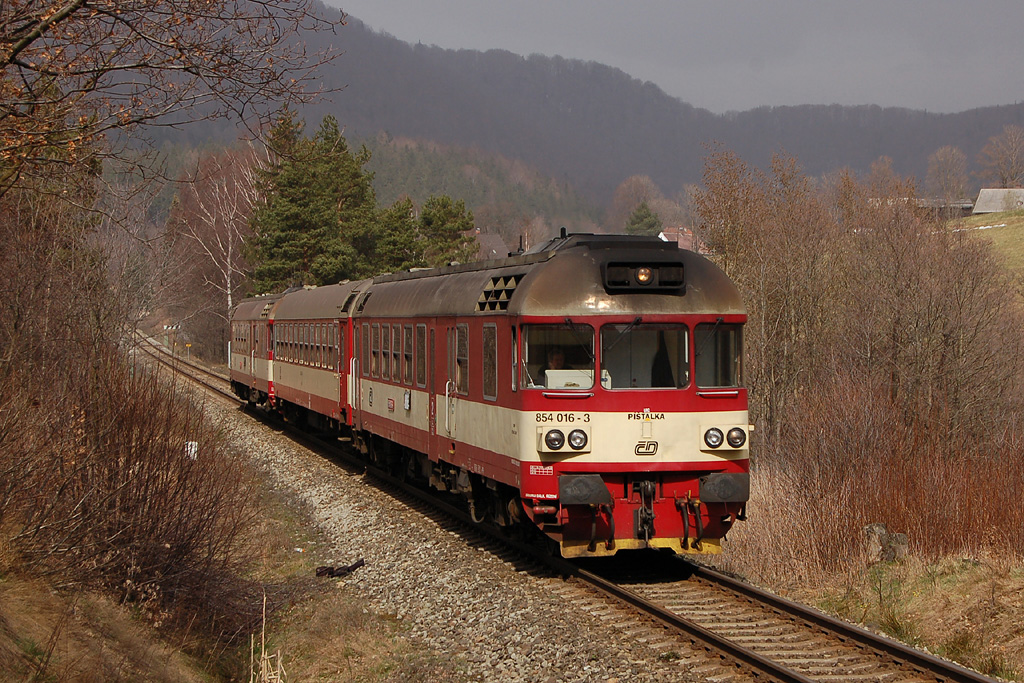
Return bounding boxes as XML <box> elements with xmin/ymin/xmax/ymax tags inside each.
<box><xmin>0</xmin><ymin>0</ymin><xmax>344</xmax><ymax>194</ymax></box>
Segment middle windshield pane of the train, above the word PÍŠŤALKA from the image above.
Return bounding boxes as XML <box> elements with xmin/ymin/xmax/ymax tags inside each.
<box><xmin>601</xmin><ymin>323</ymin><xmax>690</xmax><ymax>389</ymax></box>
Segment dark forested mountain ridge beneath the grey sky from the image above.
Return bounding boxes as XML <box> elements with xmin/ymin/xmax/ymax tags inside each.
<box><xmin>303</xmin><ymin>9</ymin><xmax>1024</xmax><ymax>205</ymax></box>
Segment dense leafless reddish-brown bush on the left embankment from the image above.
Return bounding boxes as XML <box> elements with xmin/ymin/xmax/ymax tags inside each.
<box><xmin>0</xmin><ymin>349</ymin><xmax>258</xmax><ymax>635</ymax></box>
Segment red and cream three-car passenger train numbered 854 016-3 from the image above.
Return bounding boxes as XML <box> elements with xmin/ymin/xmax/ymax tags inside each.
<box><xmin>228</xmin><ymin>230</ymin><xmax>753</xmax><ymax>558</ymax></box>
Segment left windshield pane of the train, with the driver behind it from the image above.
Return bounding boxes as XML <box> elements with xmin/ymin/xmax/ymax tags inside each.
<box><xmin>519</xmin><ymin>325</ymin><xmax>594</xmax><ymax>389</ymax></box>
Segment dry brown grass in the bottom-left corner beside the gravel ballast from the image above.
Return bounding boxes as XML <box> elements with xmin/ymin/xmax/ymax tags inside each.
<box><xmin>0</xmin><ymin>448</ymin><xmax>462</xmax><ymax>683</ymax></box>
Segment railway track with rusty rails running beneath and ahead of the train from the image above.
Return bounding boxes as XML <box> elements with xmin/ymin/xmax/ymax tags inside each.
<box><xmin>138</xmin><ymin>340</ymin><xmax>995</xmax><ymax>683</ymax></box>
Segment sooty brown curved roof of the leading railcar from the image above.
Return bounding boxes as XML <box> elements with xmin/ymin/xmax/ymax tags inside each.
<box><xmin>358</xmin><ymin>234</ymin><xmax>745</xmax><ymax>316</ymax></box>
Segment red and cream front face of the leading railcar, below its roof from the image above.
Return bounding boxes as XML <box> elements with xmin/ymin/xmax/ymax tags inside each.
<box><xmin>518</xmin><ymin>315</ymin><xmax>750</xmax><ymax>557</ymax></box>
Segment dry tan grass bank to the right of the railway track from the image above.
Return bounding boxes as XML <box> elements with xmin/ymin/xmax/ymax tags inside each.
<box><xmin>716</xmin><ymin>462</ymin><xmax>1024</xmax><ymax>680</ymax></box>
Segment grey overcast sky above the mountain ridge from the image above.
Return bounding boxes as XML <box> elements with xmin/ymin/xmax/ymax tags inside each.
<box><xmin>327</xmin><ymin>0</ymin><xmax>1024</xmax><ymax>113</ymax></box>
